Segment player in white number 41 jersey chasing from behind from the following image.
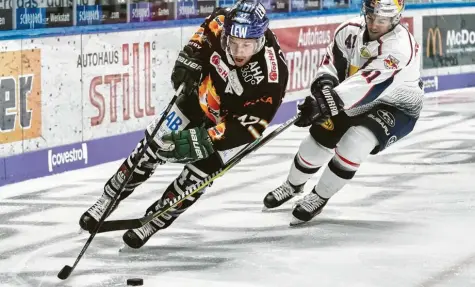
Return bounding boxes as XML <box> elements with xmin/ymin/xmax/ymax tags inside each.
<box><xmin>264</xmin><ymin>0</ymin><xmax>424</xmax><ymax>225</ymax></box>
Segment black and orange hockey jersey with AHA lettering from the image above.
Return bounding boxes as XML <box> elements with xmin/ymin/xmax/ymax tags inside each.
<box><xmin>187</xmin><ymin>8</ymin><xmax>289</xmax><ymax>150</ymax></box>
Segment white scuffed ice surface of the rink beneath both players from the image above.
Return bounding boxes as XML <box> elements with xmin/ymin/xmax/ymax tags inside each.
<box><xmin>0</xmin><ymin>89</ymin><xmax>475</xmax><ymax>287</ymax></box>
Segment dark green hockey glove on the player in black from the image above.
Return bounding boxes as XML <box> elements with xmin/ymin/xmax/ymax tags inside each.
<box><xmin>158</xmin><ymin>127</ymin><xmax>214</xmax><ymax>163</ymax></box>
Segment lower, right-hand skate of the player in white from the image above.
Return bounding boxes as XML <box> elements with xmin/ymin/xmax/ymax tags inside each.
<box><xmin>290</xmin><ymin>191</ymin><xmax>328</xmax><ymax>226</ymax></box>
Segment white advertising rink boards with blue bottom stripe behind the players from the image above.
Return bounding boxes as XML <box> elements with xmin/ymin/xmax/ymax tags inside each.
<box><xmin>0</xmin><ymin>7</ymin><xmax>475</xmax><ymax>186</ymax></box>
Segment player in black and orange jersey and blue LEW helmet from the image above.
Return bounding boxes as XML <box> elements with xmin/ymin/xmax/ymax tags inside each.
<box><xmin>79</xmin><ymin>1</ymin><xmax>288</xmax><ymax>248</ymax></box>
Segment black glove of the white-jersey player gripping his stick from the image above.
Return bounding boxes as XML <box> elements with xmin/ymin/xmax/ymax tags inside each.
<box><xmin>295</xmin><ymin>80</ymin><xmax>343</xmax><ymax>127</ymax></box>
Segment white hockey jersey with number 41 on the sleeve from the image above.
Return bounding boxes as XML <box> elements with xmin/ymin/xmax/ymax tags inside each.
<box><xmin>316</xmin><ymin>17</ymin><xmax>424</xmax><ymax>118</ymax></box>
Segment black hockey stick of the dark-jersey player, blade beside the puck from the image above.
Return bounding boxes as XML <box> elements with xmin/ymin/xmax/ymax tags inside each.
<box><xmin>58</xmin><ymin>83</ymin><xmax>185</xmax><ymax>280</ymax></box>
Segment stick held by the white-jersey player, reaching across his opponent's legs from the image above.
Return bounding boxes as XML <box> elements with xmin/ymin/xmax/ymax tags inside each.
<box><xmin>99</xmin><ymin>114</ymin><xmax>300</xmax><ymax>233</ymax></box>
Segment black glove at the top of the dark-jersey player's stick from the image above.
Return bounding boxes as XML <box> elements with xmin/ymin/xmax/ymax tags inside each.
<box><xmin>172</xmin><ymin>46</ymin><xmax>203</xmax><ymax>95</ymax></box>
